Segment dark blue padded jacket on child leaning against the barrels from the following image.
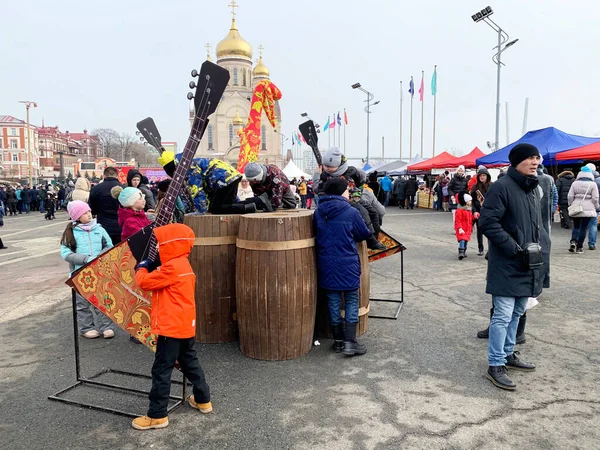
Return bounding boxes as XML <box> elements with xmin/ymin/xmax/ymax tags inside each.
<box><xmin>314</xmin><ymin>195</ymin><xmax>371</xmax><ymax>291</ymax></box>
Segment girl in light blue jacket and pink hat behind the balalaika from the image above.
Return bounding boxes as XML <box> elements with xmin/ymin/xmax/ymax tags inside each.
<box><xmin>60</xmin><ymin>200</ymin><xmax>115</xmax><ymax>339</ymax></box>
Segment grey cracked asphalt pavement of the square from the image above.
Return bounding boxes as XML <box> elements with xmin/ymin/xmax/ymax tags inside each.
<box><xmin>0</xmin><ymin>207</ymin><xmax>600</xmax><ymax>450</ymax></box>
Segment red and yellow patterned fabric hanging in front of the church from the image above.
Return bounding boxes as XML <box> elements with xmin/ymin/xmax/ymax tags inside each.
<box><xmin>237</xmin><ymin>80</ymin><xmax>281</xmax><ymax>173</ymax></box>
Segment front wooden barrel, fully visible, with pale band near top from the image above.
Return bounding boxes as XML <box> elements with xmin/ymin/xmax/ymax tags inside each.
<box><xmin>236</xmin><ymin>210</ymin><xmax>317</xmax><ymax>361</ymax></box>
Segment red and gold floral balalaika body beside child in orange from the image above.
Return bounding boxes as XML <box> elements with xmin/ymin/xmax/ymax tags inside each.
<box><xmin>67</xmin><ymin>242</ymin><xmax>156</xmax><ymax>351</ymax></box>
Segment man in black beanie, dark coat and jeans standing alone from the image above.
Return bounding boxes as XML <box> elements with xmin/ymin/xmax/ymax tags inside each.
<box><xmin>479</xmin><ymin>144</ymin><xmax>550</xmax><ymax>390</ymax></box>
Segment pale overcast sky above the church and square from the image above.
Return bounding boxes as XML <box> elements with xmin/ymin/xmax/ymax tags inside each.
<box><xmin>0</xmin><ymin>0</ymin><xmax>600</xmax><ymax>162</ymax></box>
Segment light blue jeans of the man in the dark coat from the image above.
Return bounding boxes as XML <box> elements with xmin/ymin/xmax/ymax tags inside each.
<box><xmin>488</xmin><ymin>295</ymin><xmax>528</xmax><ymax>366</ymax></box>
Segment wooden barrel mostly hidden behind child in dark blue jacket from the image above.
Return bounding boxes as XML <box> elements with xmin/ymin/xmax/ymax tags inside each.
<box><xmin>315</xmin><ymin>241</ymin><xmax>371</xmax><ymax>338</ymax></box>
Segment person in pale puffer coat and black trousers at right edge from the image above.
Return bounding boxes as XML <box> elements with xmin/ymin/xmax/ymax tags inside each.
<box><xmin>568</xmin><ymin>166</ymin><xmax>600</xmax><ymax>253</ymax></box>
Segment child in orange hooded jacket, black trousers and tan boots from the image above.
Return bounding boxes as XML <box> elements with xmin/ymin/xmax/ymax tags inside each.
<box><xmin>132</xmin><ymin>223</ymin><xmax>212</xmax><ymax>430</ymax></box>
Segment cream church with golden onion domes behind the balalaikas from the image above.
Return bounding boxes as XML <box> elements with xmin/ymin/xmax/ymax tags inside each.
<box><xmin>190</xmin><ymin>0</ymin><xmax>283</xmax><ymax>167</ymax></box>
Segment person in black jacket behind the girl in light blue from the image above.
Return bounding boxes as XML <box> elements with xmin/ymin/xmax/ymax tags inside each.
<box><xmin>88</xmin><ymin>167</ymin><xmax>121</xmax><ymax>245</ymax></box>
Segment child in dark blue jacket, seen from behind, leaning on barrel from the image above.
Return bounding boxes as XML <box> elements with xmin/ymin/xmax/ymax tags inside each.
<box><xmin>314</xmin><ymin>177</ymin><xmax>371</xmax><ymax>356</ymax></box>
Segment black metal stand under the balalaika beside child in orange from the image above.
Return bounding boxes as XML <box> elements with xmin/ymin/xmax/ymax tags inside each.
<box><xmin>48</xmin><ymin>290</ymin><xmax>187</xmax><ymax>417</ymax></box>
